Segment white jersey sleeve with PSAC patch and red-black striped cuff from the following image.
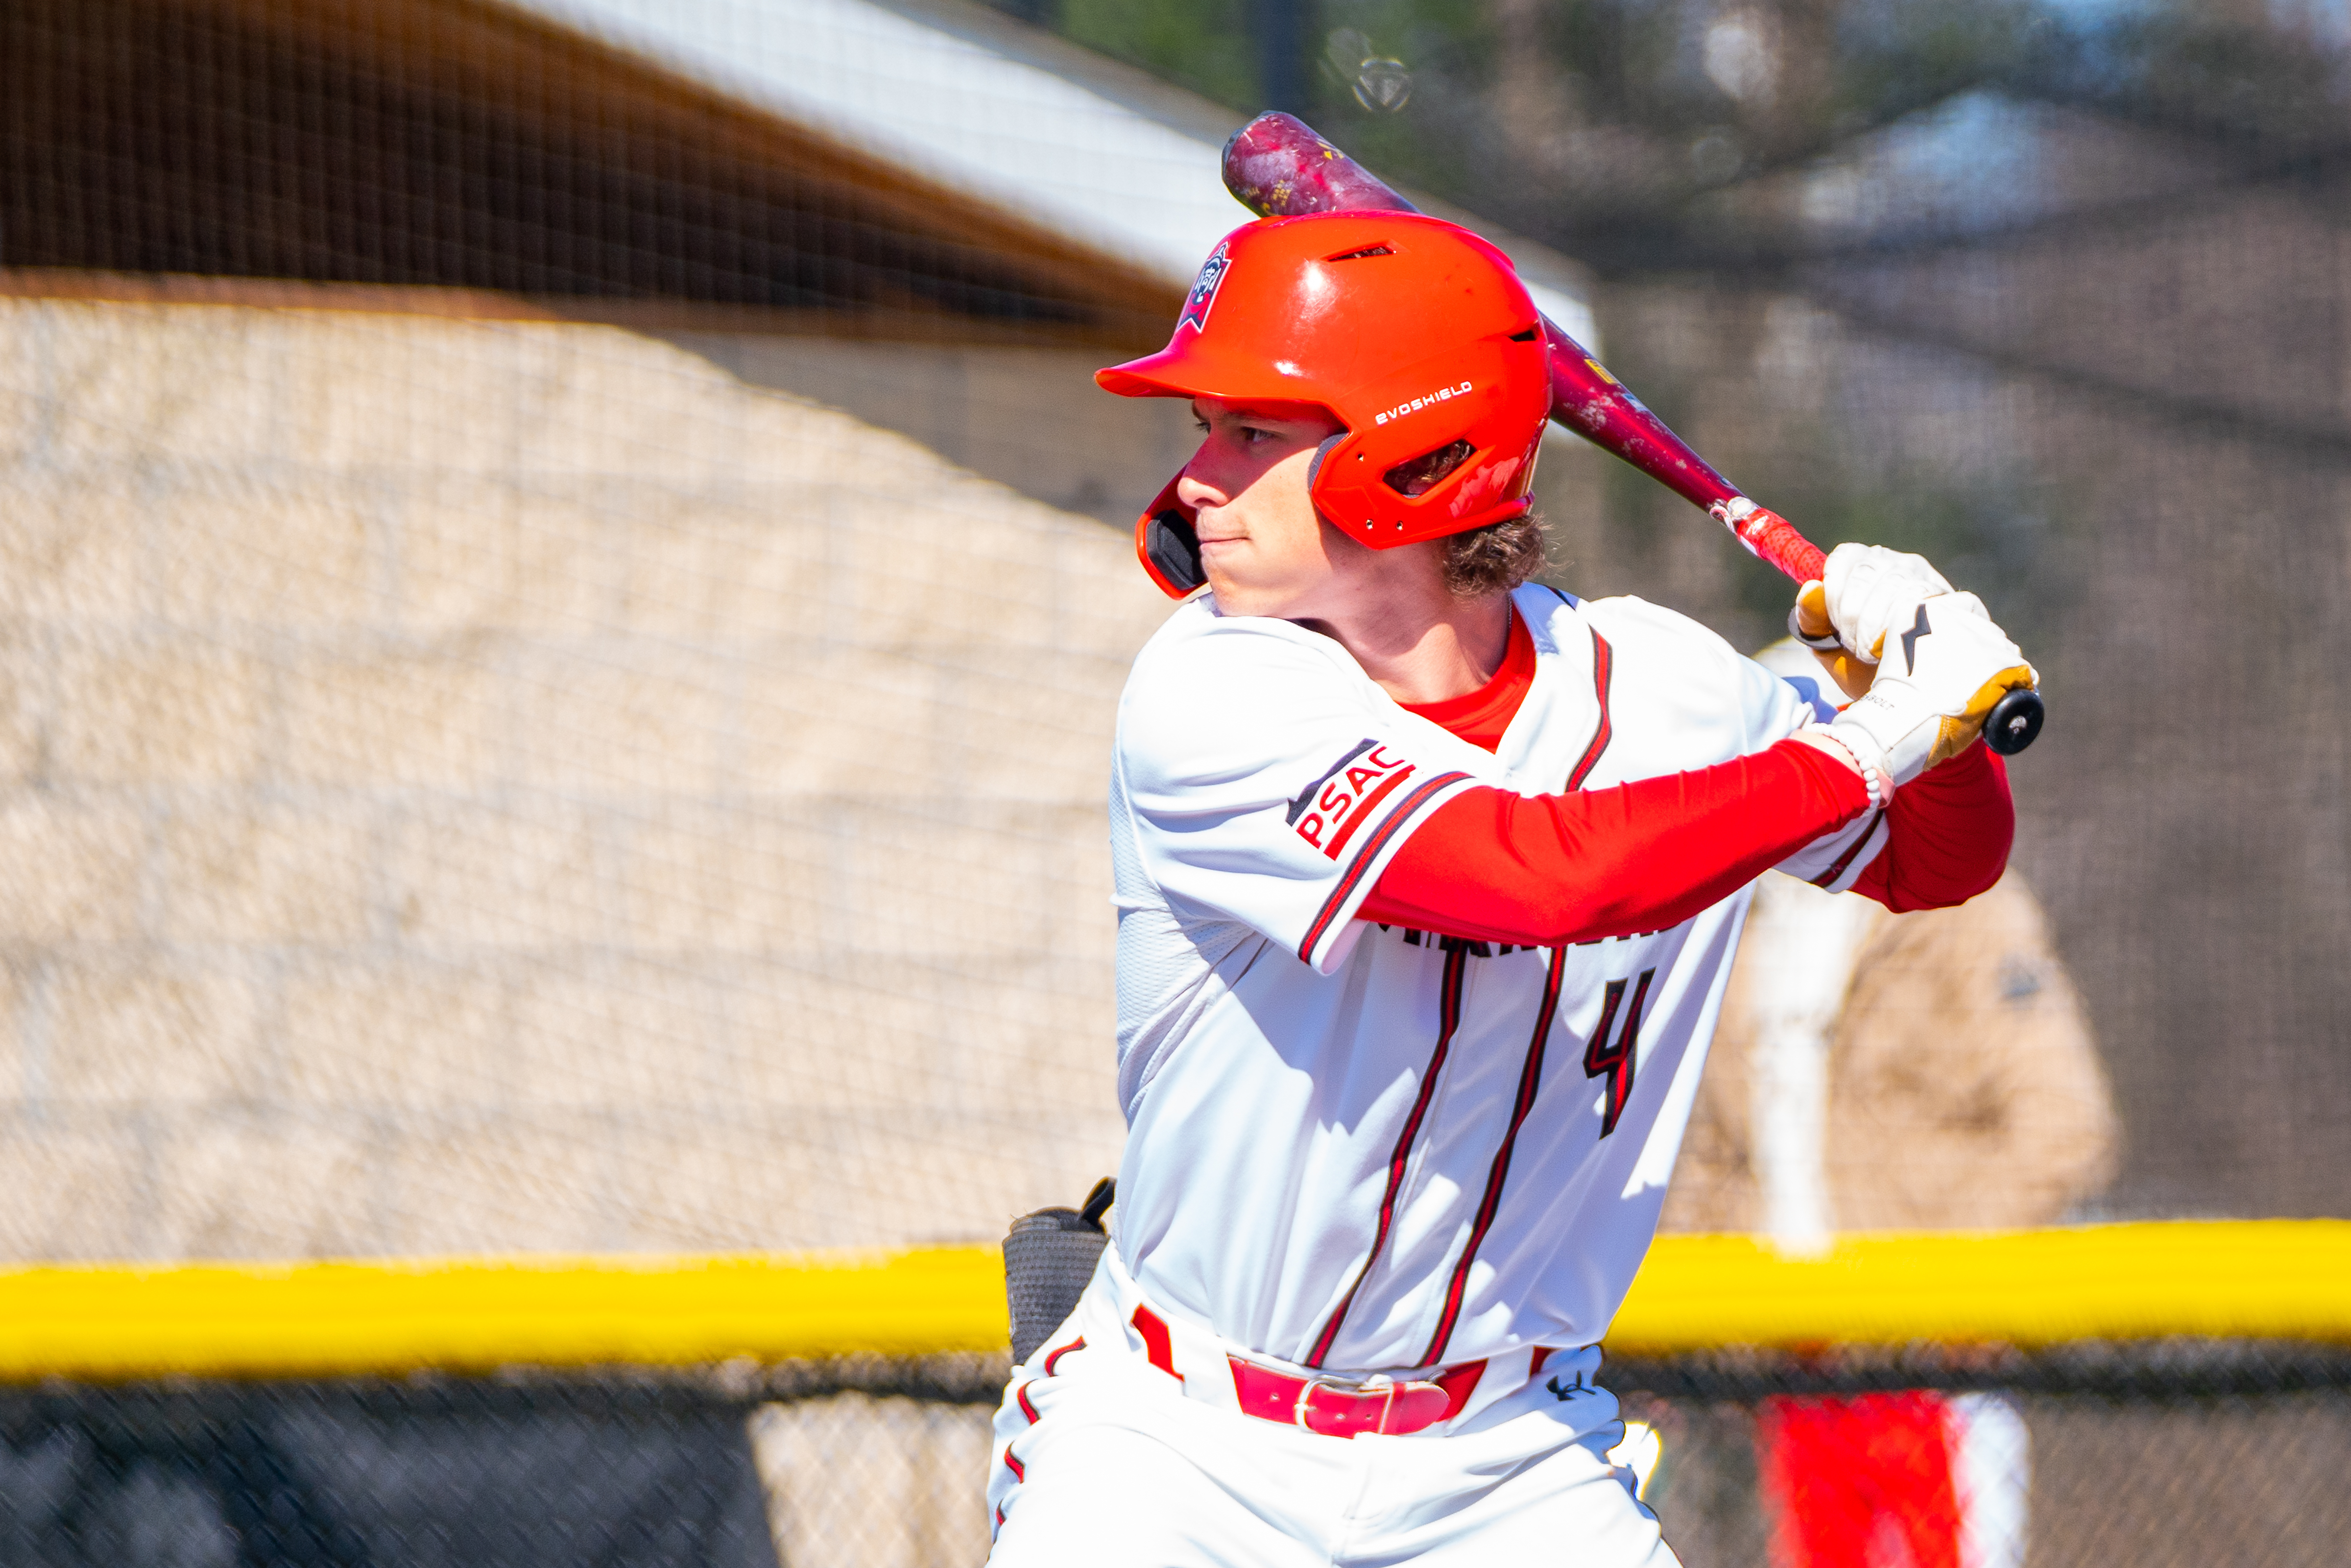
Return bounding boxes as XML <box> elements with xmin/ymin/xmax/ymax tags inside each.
<box><xmin>1112</xmin><ymin>618</ymin><xmax>1474</xmax><ymax>973</ymax></box>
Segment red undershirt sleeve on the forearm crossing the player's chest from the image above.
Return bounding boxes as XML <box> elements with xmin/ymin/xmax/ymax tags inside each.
<box><xmin>1357</xmin><ymin>740</ymin><xmax>1869</xmax><ymax>948</ymax></box>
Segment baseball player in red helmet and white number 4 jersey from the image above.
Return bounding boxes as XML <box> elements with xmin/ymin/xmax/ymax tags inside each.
<box><xmin>990</xmin><ymin>212</ymin><xmax>2031</xmax><ymax>1568</ymax></box>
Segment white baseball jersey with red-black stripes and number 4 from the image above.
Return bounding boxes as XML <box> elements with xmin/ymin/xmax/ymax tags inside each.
<box><xmin>1110</xmin><ymin>588</ymin><xmax>1886</xmax><ymax>1373</ymax></box>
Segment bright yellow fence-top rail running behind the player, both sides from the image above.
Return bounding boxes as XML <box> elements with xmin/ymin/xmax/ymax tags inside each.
<box><xmin>0</xmin><ymin>1220</ymin><xmax>2351</xmax><ymax>1380</ymax></box>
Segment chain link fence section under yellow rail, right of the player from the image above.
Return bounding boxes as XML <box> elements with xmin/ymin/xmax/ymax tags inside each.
<box><xmin>1604</xmin><ymin>1340</ymin><xmax>2351</xmax><ymax>1568</ymax></box>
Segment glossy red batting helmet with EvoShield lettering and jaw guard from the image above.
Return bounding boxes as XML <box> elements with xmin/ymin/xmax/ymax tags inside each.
<box><xmin>1096</xmin><ymin>212</ymin><xmax>1552</xmax><ymax>597</ymax></box>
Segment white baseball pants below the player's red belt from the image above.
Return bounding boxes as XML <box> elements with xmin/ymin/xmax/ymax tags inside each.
<box><xmin>987</xmin><ymin>1248</ymin><xmax>1676</xmax><ymax>1568</ymax></box>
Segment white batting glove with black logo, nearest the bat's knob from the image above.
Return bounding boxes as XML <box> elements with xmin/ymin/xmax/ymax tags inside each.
<box><xmin>1829</xmin><ymin>592</ymin><xmax>2040</xmax><ymax>785</ymax></box>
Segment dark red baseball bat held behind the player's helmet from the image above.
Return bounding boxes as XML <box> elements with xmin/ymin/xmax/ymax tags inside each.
<box><xmin>1225</xmin><ymin>113</ymin><xmax>2045</xmax><ymax>757</ymax></box>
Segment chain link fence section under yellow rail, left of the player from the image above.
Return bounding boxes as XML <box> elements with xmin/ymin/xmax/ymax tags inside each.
<box><xmin>0</xmin><ymin>1356</ymin><xmax>1004</xmax><ymax>1568</ymax></box>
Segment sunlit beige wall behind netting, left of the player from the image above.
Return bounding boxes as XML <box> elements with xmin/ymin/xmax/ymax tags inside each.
<box><xmin>0</xmin><ymin>301</ymin><xmax>1164</xmax><ymax>1258</ymax></box>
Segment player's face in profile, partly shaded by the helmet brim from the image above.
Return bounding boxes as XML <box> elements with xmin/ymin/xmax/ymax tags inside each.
<box><xmin>1176</xmin><ymin>397</ymin><xmax>1420</xmax><ymax>620</ymax></box>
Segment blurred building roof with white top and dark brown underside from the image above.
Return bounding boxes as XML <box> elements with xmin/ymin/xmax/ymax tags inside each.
<box><xmin>0</xmin><ymin>0</ymin><xmax>1589</xmax><ymax>348</ymax></box>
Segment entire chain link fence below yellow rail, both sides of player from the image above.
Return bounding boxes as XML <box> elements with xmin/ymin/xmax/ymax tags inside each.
<box><xmin>0</xmin><ymin>1340</ymin><xmax>2351</xmax><ymax>1568</ymax></box>
